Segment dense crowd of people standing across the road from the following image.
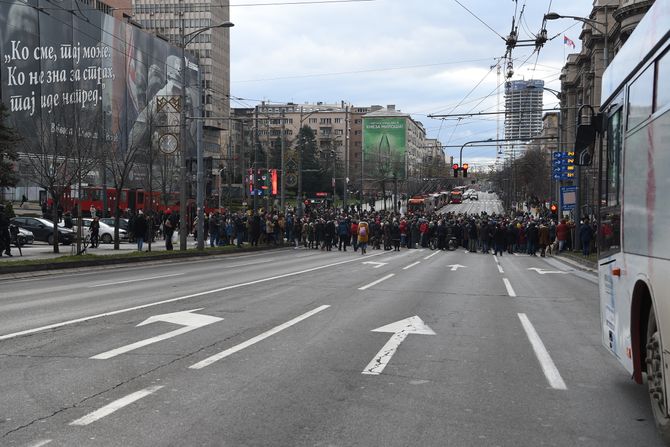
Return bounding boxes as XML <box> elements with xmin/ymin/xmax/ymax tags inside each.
<box><xmin>123</xmin><ymin>201</ymin><xmax>594</xmax><ymax>256</ymax></box>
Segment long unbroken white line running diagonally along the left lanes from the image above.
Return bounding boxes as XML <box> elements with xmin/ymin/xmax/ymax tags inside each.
<box><xmin>0</xmin><ymin>253</ymin><xmax>384</xmax><ymax>341</ymax></box>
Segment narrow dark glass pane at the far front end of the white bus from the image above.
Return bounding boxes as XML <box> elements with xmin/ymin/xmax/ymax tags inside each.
<box><xmin>598</xmin><ymin>107</ymin><xmax>623</xmax><ymax>257</ymax></box>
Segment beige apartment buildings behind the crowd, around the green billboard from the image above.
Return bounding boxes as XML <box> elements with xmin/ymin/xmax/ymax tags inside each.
<box><xmin>228</xmin><ymin>102</ymin><xmax>446</xmax><ymax>201</ymax></box>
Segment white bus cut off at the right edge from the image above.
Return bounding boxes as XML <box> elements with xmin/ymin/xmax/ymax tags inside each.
<box><xmin>598</xmin><ymin>0</ymin><xmax>670</xmax><ymax>442</ymax></box>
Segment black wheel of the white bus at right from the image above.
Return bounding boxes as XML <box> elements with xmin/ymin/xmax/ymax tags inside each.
<box><xmin>647</xmin><ymin>307</ymin><xmax>670</xmax><ymax>442</ymax></box>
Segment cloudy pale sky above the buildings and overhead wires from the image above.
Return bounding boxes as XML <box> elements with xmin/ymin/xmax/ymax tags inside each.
<box><xmin>230</xmin><ymin>0</ymin><xmax>592</xmax><ymax>170</ymax></box>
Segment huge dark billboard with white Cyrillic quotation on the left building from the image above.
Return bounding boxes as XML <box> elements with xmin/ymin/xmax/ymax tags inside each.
<box><xmin>0</xmin><ymin>0</ymin><xmax>200</xmax><ymax>186</ymax></box>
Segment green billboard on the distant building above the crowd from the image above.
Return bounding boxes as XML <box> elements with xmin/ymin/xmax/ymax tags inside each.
<box><xmin>363</xmin><ymin>116</ymin><xmax>407</xmax><ymax>180</ymax></box>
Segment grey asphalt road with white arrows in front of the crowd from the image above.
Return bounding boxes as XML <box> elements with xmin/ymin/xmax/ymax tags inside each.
<box><xmin>0</xmin><ymin>249</ymin><xmax>662</xmax><ymax>447</ymax></box>
